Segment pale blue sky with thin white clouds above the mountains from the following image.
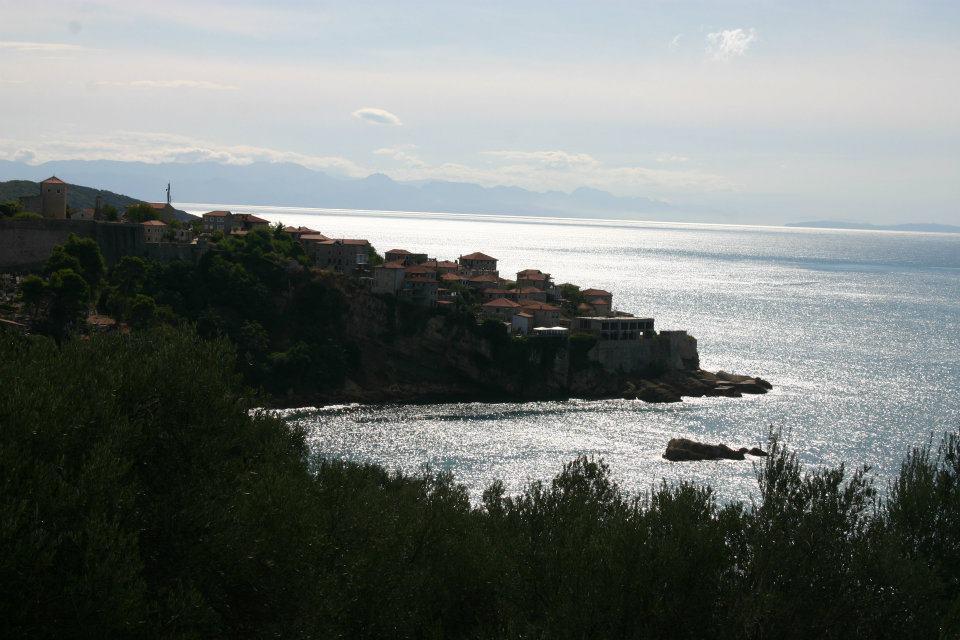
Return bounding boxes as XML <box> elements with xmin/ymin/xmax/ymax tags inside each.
<box><xmin>0</xmin><ymin>0</ymin><xmax>960</xmax><ymax>224</ymax></box>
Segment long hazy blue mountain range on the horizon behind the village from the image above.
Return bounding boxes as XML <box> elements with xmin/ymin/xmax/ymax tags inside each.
<box><xmin>0</xmin><ymin>160</ymin><xmax>703</xmax><ymax>221</ymax></box>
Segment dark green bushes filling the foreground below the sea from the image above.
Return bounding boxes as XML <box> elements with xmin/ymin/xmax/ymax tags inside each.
<box><xmin>0</xmin><ymin>329</ymin><xmax>960</xmax><ymax>638</ymax></box>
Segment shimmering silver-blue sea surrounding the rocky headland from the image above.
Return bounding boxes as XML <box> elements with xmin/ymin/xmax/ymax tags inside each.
<box><xmin>181</xmin><ymin>205</ymin><xmax>960</xmax><ymax>499</ymax></box>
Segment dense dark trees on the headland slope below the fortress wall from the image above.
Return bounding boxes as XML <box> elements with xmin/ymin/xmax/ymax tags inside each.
<box><xmin>21</xmin><ymin>230</ymin><xmax>368</xmax><ymax>397</ymax></box>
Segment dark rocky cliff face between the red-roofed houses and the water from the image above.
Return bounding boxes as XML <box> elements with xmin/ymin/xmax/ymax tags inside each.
<box><xmin>304</xmin><ymin>288</ymin><xmax>724</xmax><ymax>402</ymax></box>
